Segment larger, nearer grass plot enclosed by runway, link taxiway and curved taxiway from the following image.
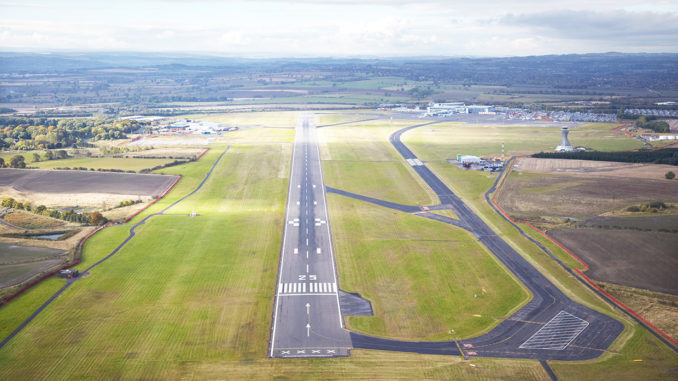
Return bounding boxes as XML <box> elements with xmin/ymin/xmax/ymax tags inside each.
<box><xmin>329</xmin><ymin>195</ymin><xmax>528</xmax><ymax>340</ymax></box>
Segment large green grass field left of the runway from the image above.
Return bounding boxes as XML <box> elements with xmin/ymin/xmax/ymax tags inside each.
<box><xmin>0</xmin><ymin>146</ymin><xmax>291</xmax><ymax>379</ymax></box>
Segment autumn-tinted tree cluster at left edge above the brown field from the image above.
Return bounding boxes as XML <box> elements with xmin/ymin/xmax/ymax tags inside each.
<box><xmin>0</xmin><ymin>117</ymin><xmax>144</xmax><ymax>150</ymax></box>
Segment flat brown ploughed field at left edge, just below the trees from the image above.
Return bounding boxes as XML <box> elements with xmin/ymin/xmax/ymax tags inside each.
<box><xmin>0</xmin><ymin>169</ymin><xmax>177</xmax><ymax>196</ymax></box>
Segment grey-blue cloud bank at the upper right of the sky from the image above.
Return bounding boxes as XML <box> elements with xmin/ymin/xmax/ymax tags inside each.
<box><xmin>499</xmin><ymin>10</ymin><xmax>678</xmax><ymax>46</ymax></box>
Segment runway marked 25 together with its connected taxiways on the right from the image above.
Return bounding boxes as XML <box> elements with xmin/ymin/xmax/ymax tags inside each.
<box><xmin>270</xmin><ymin>116</ymin><xmax>624</xmax><ymax>360</ymax></box>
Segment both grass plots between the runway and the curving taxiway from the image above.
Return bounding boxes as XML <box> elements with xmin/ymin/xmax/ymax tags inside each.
<box><xmin>320</xmin><ymin>120</ymin><xmax>528</xmax><ymax>340</ymax></box>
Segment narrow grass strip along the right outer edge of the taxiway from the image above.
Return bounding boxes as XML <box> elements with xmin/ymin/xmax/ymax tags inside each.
<box><xmin>404</xmin><ymin>127</ymin><xmax>678</xmax><ymax>380</ymax></box>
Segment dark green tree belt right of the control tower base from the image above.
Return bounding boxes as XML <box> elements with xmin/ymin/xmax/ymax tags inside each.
<box><xmin>532</xmin><ymin>148</ymin><xmax>678</xmax><ymax>165</ymax></box>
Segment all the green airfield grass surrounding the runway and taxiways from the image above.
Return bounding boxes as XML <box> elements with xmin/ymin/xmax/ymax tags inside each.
<box><xmin>0</xmin><ymin>111</ymin><xmax>678</xmax><ymax>380</ymax></box>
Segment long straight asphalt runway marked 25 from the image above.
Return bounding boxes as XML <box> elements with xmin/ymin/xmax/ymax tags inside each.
<box><xmin>269</xmin><ymin>114</ymin><xmax>351</xmax><ymax>358</ymax></box>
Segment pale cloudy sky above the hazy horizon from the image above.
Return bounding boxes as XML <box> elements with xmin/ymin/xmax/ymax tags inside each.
<box><xmin>0</xmin><ymin>0</ymin><xmax>678</xmax><ymax>58</ymax></box>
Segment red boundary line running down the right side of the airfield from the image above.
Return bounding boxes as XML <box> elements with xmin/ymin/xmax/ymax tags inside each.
<box><xmin>489</xmin><ymin>159</ymin><xmax>678</xmax><ymax>351</ymax></box>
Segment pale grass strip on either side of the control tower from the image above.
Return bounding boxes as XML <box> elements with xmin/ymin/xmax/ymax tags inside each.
<box><xmin>403</xmin><ymin>123</ymin><xmax>643</xmax><ymax>161</ymax></box>
